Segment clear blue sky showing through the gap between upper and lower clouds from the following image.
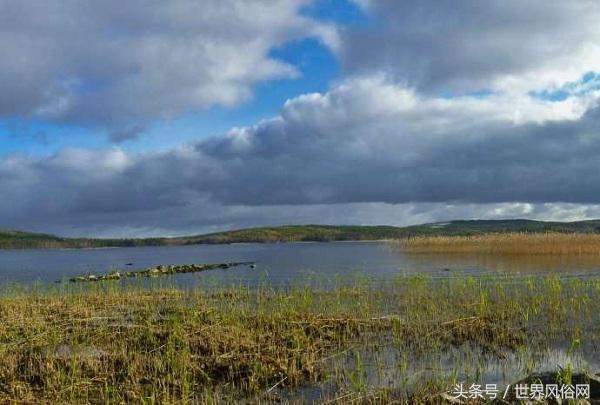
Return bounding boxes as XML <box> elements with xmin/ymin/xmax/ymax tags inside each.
<box><xmin>0</xmin><ymin>0</ymin><xmax>368</xmax><ymax>156</ymax></box>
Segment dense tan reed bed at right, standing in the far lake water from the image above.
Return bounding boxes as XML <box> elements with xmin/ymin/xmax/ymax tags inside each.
<box><xmin>392</xmin><ymin>233</ymin><xmax>600</xmax><ymax>255</ymax></box>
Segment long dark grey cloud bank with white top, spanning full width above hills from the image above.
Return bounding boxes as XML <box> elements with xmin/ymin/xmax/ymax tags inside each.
<box><xmin>0</xmin><ymin>75</ymin><xmax>600</xmax><ymax>234</ymax></box>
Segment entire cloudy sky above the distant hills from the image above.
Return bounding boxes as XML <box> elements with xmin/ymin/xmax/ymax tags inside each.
<box><xmin>0</xmin><ymin>0</ymin><xmax>600</xmax><ymax>237</ymax></box>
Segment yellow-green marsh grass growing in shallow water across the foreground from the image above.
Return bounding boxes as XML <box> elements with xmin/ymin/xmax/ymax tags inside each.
<box><xmin>0</xmin><ymin>276</ymin><xmax>600</xmax><ymax>403</ymax></box>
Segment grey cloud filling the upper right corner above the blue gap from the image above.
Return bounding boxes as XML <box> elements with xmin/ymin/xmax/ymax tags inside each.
<box><xmin>340</xmin><ymin>0</ymin><xmax>600</xmax><ymax>94</ymax></box>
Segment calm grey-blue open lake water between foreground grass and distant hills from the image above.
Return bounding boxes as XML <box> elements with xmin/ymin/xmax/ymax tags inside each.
<box><xmin>0</xmin><ymin>242</ymin><xmax>600</xmax><ymax>286</ymax></box>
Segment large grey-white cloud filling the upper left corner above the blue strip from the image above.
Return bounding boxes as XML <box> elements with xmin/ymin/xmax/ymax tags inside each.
<box><xmin>0</xmin><ymin>0</ymin><xmax>337</xmax><ymax>133</ymax></box>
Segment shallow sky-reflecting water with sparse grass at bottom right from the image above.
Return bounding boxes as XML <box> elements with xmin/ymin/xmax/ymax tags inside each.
<box><xmin>279</xmin><ymin>339</ymin><xmax>600</xmax><ymax>403</ymax></box>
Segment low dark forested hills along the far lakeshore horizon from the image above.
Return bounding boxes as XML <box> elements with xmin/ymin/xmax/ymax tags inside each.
<box><xmin>0</xmin><ymin>219</ymin><xmax>600</xmax><ymax>249</ymax></box>
